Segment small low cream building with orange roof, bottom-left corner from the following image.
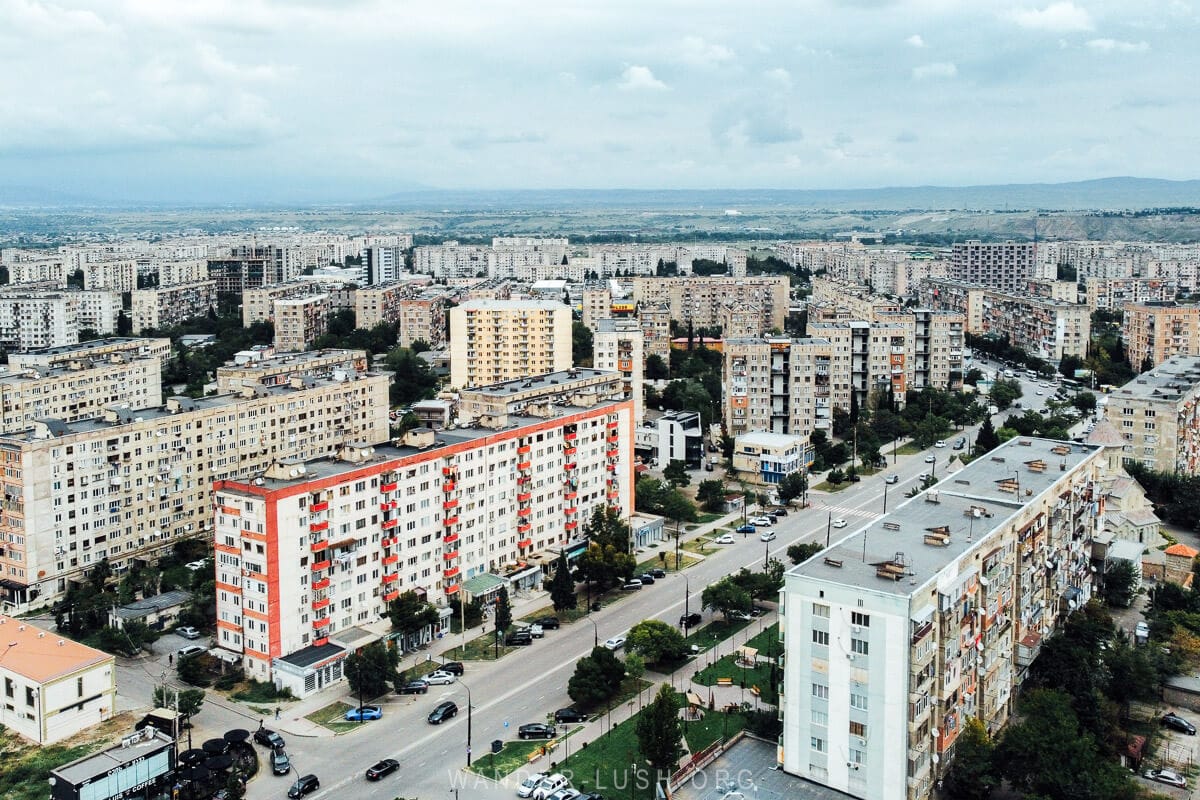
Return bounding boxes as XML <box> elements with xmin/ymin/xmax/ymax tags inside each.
<box><xmin>0</xmin><ymin>615</ymin><xmax>116</xmax><ymax>745</ymax></box>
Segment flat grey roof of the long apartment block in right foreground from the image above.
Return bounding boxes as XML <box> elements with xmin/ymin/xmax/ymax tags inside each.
<box><xmin>788</xmin><ymin>437</ymin><xmax>1102</xmax><ymax>596</ymax></box>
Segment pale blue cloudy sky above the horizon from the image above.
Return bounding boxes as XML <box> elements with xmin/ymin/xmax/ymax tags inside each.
<box><xmin>0</xmin><ymin>0</ymin><xmax>1200</xmax><ymax>203</ymax></box>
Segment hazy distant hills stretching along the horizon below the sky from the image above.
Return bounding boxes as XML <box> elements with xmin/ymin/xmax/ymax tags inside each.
<box><xmin>0</xmin><ymin>178</ymin><xmax>1200</xmax><ymax>212</ymax></box>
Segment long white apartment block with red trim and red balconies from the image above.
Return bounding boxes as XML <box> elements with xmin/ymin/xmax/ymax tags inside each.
<box><xmin>215</xmin><ymin>383</ymin><xmax>634</xmax><ymax>697</ymax></box>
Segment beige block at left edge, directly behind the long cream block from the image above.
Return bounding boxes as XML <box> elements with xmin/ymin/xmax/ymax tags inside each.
<box><xmin>0</xmin><ymin>354</ymin><xmax>162</xmax><ymax>432</ymax></box>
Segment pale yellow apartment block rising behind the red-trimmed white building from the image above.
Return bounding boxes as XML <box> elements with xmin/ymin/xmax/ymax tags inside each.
<box><xmin>450</xmin><ymin>300</ymin><xmax>571</xmax><ymax>389</ymax></box>
